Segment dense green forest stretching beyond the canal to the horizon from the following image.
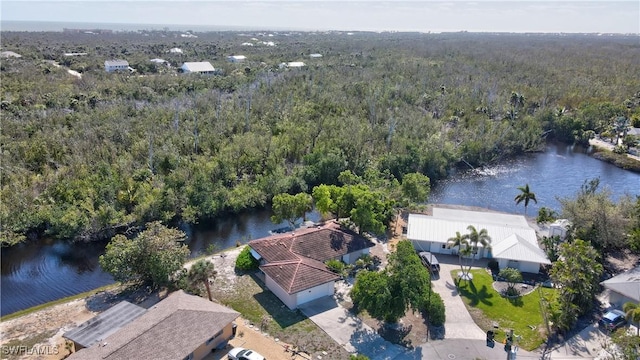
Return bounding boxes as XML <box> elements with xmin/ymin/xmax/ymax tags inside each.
<box><xmin>0</xmin><ymin>31</ymin><xmax>640</xmax><ymax>246</ymax></box>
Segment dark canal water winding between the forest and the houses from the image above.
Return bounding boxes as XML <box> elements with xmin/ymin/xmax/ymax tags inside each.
<box><xmin>0</xmin><ymin>144</ymin><xmax>640</xmax><ymax>315</ymax></box>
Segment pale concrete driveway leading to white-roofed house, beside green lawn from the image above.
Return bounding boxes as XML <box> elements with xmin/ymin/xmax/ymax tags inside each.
<box><xmin>431</xmin><ymin>254</ymin><xmax>486</xmax><ymax>340</ymax></box>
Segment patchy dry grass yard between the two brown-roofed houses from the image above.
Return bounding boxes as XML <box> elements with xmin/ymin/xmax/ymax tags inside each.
<box><xmin>212</xmin><ymin>275</ymin><xmax>349</xmax><ymax>359</ymax></box>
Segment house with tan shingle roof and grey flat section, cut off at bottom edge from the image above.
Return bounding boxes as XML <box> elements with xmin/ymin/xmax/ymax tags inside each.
<box><xmin>63</xmin><ymin>290</ymin><xmax>240</xmax><ymax>360</ymax></box>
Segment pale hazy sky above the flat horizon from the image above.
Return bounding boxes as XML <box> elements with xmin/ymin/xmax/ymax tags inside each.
<box><xmin>0</xmin><ymin>0</ymin><xmax>640</xmax><ymax>34</ymax></box>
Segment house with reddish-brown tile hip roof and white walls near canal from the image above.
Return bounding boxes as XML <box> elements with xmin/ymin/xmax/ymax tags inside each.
<box><xmin>249</xmin><ymin>221</ymin><xmax>374</xmax><ymax>309</ymax></box>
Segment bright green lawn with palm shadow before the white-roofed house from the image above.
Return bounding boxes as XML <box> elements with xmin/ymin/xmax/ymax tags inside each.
<box><xmin>451</xmin><ymin>270</ymin><xmax>553</xmax><ymax>350</ymax></box>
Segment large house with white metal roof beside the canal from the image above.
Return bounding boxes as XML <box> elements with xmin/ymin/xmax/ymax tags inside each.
<box><xmin>407</xmin><ymin>208</ymin><xmax>551</xmax><ymax>273</ymax></box>
